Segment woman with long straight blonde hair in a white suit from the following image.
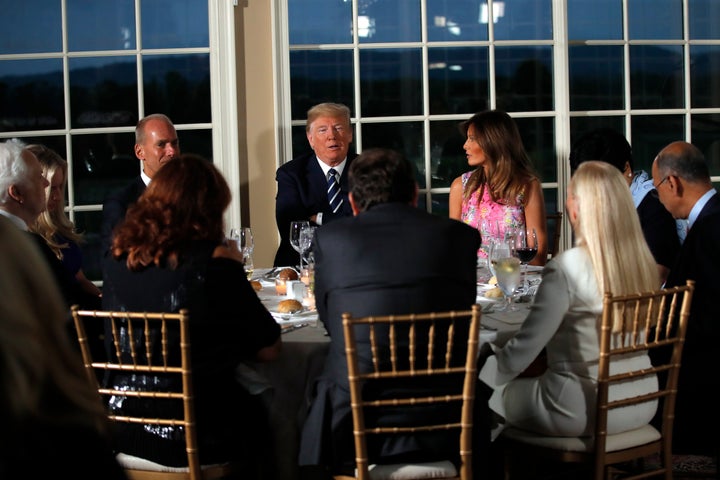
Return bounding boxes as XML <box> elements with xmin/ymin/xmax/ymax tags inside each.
<box><xmin>480</xmin><ymin>161</ymin><xmax>660</xmax><ymax>436</ymax></box>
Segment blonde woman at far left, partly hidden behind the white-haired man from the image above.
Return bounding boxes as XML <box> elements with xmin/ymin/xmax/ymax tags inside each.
<box><xmin>25</xmin><ymin>144</ymin><xmax>100</xmax><ymax>296</ymax></box>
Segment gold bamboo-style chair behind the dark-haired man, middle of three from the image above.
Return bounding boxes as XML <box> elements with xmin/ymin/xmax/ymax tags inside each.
<box><xmin>343</xmin><ymin>305</ymin><xmax>481</xmax><ymax>480</ymax></box>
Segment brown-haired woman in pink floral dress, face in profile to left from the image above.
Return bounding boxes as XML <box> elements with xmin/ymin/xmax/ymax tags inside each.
<box><xmin>449</xmin><ymin>110</ymin><xmax>547</xmax><ymax>265</ymax></box>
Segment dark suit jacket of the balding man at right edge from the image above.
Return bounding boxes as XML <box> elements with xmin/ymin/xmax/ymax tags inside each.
<box><xmin>666</xmin><ymin>194</ymin><xmax>720</xmax><ymax>454</ymax></box>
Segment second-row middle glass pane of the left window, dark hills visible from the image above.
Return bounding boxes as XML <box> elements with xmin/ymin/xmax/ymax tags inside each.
<box><xmin>68</xmin><ymin>56</ymin><xmax>138</xmax><ymax>128</ymax></box>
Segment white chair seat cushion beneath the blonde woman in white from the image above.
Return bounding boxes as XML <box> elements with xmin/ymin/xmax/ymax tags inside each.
<box><xmin>501</xmin><ymin>425</ymin><xmax>660</xmax><ymax>452</ymax></box>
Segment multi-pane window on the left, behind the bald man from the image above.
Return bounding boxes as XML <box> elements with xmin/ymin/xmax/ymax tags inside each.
<box><xmin>0</xmin><ymin>0</ymin><xmax>237</xmax><ymax>281</ymax></box>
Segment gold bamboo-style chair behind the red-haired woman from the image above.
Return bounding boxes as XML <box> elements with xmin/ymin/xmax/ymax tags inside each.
<box><xmin>71</xmin><ymin>305</ymin><xmax>235</xmax><ymax>480</ymax></box>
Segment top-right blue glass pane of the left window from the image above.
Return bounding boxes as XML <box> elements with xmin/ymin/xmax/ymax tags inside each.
<box><xmin>141</xmin><ymin>0</ymin><xmax>209</xmax><ymax>48</ymax></box>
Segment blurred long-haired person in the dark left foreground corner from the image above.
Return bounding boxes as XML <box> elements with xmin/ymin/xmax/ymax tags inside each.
<box><xmin>0</xmin><ymin>217</ymin><xmax>126</xmax><ymax>480</ymax></box>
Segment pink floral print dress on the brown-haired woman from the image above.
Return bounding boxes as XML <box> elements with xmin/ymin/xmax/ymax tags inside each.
<box><xmin>460</xmin><ymin>172</ymin><xmax>525</xmax><ymax>258</ymax></box>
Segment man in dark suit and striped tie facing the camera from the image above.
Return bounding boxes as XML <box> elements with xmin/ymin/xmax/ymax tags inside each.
<box><xmin>273</xmin><ymin>103</ymin><xmax>357</xmax><ymax>267</ymax></box>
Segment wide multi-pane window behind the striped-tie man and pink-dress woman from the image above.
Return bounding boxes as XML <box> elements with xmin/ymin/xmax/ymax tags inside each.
<box><xmin>275</xmin><ymin>0</ymin><xmax>720</xmax><ymax>235</ymax></box>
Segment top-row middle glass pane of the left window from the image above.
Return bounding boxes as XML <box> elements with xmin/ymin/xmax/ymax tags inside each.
<box><xmin>67</xmin><ymin>0</ymin><xmax>136</xmax><ymax>52</ymax></box>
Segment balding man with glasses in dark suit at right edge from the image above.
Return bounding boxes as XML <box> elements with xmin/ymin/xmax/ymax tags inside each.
<box><xmin>652</xmin><ymin>142</ymin><xmax>720</xmax><ymax>455</ymax></box>
